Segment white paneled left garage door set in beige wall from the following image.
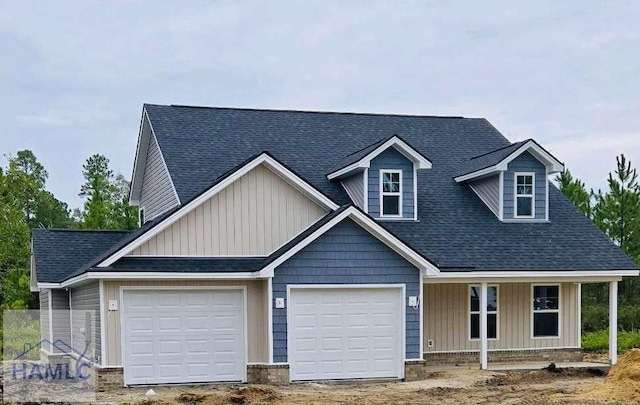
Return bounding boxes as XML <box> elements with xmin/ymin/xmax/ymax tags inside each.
<box><xmin>122</xmin><ymin>289</ymin><xmax>246</xmax><ymax>385</ymax></box>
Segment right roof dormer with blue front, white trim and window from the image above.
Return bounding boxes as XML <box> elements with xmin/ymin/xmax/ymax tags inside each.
<box><xmin>454</xmin><ymin>139</ymin><xmax>564</xmax><ymax>222</ymax></box>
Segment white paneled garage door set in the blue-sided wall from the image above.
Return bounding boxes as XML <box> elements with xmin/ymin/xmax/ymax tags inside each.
<box><xmin>288</xmin><ymin>288</ymin><xmax>404</xmax><ymax>380</ymax></box>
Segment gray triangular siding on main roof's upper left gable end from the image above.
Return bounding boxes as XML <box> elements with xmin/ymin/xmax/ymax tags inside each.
<box><xmin>140</xmin><ymin>129</ymin><xmax>179</xmax><ymax>221</ymax></box>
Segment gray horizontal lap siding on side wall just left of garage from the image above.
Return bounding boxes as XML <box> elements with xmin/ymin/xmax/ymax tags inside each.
<box><xmin>69</xmin><ymin>281</ymin><xmax>101</xmax><ymax>360</ymax></box>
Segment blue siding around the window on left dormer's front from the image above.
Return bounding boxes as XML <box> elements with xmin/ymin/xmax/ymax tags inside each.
<box><xmin>369</xmin><ymin>148</ymin><xmax>415</xmax><ymax>219</ymax></box>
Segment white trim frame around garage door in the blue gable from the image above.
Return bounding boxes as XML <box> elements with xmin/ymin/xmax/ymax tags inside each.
<box><xmin>286</xmin><ymin>284</ymin><xmax>408</xmax><ymax>379</ymax></box>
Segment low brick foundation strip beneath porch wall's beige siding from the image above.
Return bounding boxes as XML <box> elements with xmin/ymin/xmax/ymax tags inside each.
<box><xmin>424</xmin><ymin>349</ymin><xmax>582</xmax><ymax>366</ymax></box>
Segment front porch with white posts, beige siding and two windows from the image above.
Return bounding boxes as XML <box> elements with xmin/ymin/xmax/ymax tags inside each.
<box><xmin>423</xmin><ymin>273</ymin><xmax>621</xmax><ymax>370</ymax></box>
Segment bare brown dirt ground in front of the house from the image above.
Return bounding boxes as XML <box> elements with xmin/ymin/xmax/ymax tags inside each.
<box><xmin>90</xmin><ymin>369</ymin><xmax>624</xmax><ymax>405</ymax></box>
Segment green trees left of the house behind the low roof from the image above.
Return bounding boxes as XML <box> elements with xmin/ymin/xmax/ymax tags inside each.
<box><xmin>0</xmin><ymin>150</ymin><xmax>138</xmax><ymax>309</ymax></box>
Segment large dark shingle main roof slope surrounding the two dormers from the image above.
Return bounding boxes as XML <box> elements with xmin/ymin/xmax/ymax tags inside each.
<box><xmin>145</xmin><ymin>105</ymin><xmax>636</xmax><ymax>270</ymax></box>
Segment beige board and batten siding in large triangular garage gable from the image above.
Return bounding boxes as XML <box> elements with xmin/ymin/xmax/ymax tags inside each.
<box><xmin>129</xmin><ymin>165</ymin><xmax>327</xmax><ymax>256</ymax></box>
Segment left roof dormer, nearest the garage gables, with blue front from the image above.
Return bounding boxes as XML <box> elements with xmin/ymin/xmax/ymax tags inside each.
<box><xmin>327</xmin><ymin>135</ymin><xmax>431</xmax><ymax>220</ymax></box>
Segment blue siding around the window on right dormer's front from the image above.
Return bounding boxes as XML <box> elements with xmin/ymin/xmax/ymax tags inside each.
<box><xmin>503</xmin><ymin>152</ymin><xmax>548</xmax><ymax>219</ymax></box>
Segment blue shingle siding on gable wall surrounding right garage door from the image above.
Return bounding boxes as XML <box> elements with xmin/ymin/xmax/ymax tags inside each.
<box><xmin>271</xmin><ymin>219</ymin><xmax>420</xmax><ymax>363</ymax></box>
